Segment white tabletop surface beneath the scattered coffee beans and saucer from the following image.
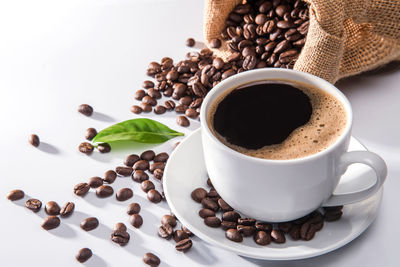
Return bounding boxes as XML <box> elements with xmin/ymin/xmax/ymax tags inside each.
<box><xmin>0</xmin><ymin>0</ymin><xmax>400</xmax><ymax>267</ymax></box>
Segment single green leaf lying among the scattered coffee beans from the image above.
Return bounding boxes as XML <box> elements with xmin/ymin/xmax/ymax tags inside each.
<box><xmin>92</xmin><ymin>118</ymin><xmax>184</xmax><ymax>144</ymax></box>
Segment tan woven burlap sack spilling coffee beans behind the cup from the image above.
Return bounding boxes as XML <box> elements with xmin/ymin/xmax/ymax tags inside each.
<box><xmin>204</xmin><ymin>0</ymin><xmax>400</xmax><ymax>83</ymax></box>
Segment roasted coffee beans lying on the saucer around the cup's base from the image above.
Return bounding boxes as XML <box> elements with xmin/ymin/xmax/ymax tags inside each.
<box><xmin>191</xmin><ymin>179</ymin><xmax>343</xmax><ymax>246</ymax></box>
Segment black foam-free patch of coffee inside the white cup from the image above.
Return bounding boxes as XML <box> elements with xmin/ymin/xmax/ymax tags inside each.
<box><xmin>212</xmin><ymin>83</ymin><xmax>312</xmax><ymax>149</ymax></box>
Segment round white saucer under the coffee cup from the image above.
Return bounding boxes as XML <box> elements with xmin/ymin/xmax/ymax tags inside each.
<box><xmin>163</xmin><ymin>129</ymin><xmax>383</xmax><ymax>260</ymax></box>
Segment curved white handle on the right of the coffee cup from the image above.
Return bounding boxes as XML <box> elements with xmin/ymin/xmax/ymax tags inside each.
<box><xmin>322</xmin><ymin>151</ymin><xmax>387</xmax><ymax>207</ymax></box>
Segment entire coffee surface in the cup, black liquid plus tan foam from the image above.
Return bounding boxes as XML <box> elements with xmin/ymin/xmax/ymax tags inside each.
<box><xmin>207</xmin><ymin>80</ymin><xmax>347</xmax><ymax>160</ymax></box>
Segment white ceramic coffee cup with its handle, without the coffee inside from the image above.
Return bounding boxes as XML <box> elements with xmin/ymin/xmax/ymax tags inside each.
<box><xmin>201</xmin><ymin>68</ymin><xmax>387</xmax><ymax>222</ymax></box>
